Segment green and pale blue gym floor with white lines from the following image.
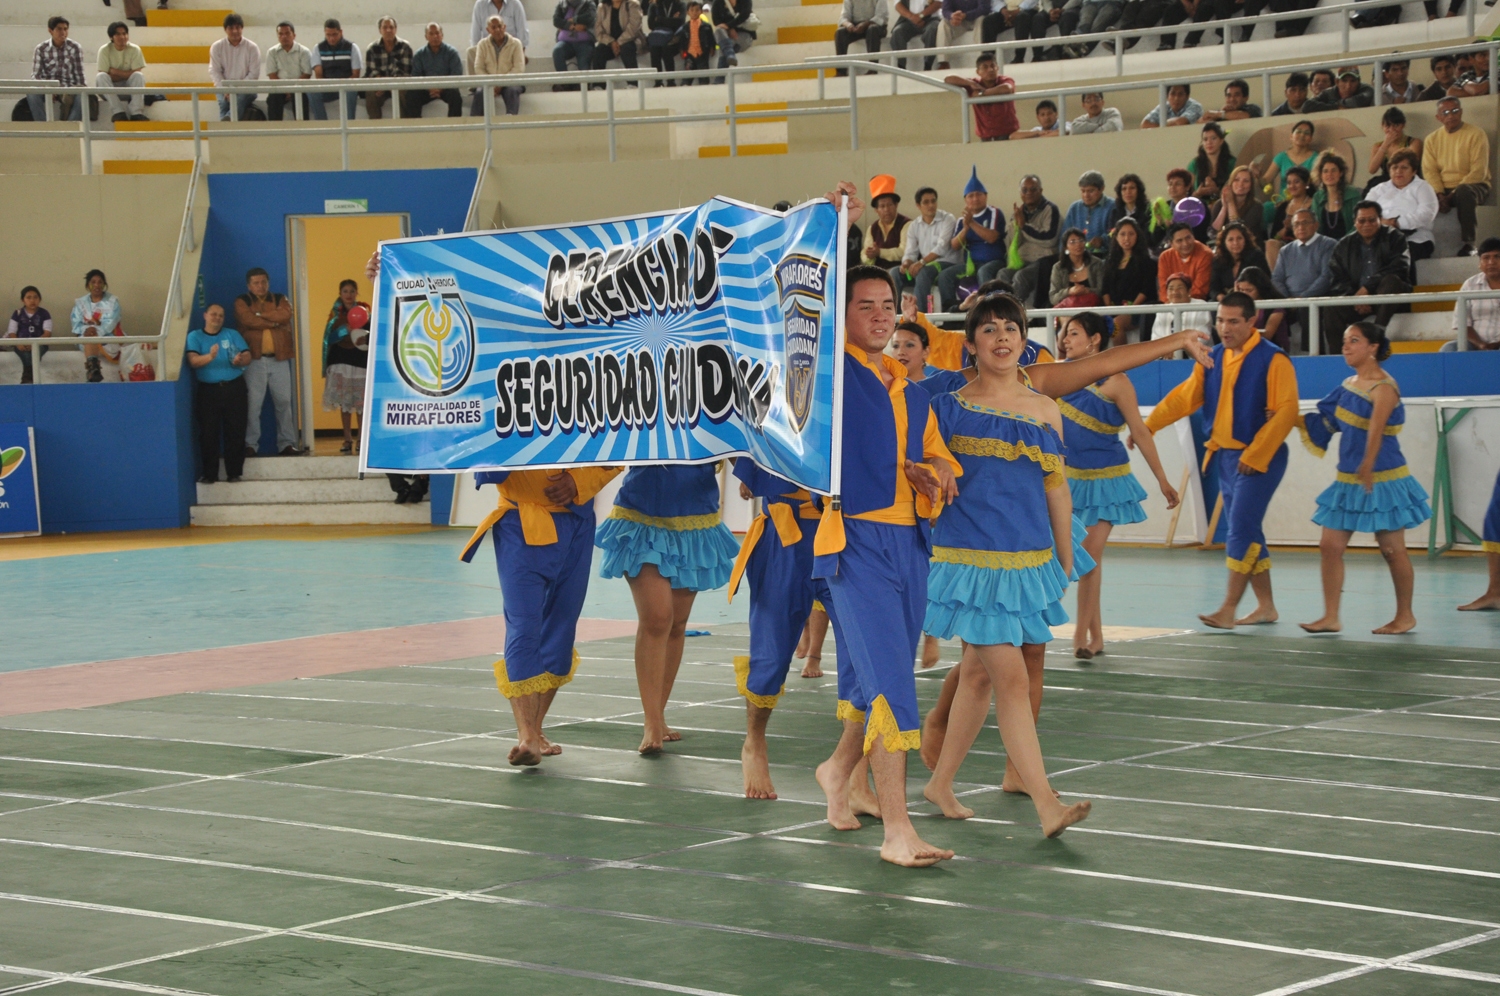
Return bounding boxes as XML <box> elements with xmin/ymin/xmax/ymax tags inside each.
<box><xmin>0</xmin><ymin>531</ymin><xmax>1500</xmax><ymax>996</ymax></box>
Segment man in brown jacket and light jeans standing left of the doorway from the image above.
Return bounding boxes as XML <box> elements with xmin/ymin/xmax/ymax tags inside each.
<box><xmin>234</xmin><ymin>267</ymin><xmax>297</xmax><ymax>456</ymax></box>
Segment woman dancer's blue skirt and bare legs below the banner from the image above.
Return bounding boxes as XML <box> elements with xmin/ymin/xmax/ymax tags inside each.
<box><xmin>594</xmin><ymin>464</ymin><xmax>740</xmax><ymax>755</ymax></box>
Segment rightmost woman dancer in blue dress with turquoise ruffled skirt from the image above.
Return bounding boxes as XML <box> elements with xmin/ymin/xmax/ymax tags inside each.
<box><xmin>1299</xmin><ymin>321</ymin><xmax>1433</xmax><ymax>635</ymax></box>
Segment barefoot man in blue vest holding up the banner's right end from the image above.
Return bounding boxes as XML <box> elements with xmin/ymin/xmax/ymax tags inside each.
<box><xmin>813</xmin><ymin>182</ymin><xmax>959</xmax><ymax>867</ymax></box>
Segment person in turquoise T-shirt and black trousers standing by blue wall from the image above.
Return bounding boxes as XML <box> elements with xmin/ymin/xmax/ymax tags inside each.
<box><xmin>188</xmin><ymin>305</ymin><xmax>251</xmax><ymax>485</ymax></box>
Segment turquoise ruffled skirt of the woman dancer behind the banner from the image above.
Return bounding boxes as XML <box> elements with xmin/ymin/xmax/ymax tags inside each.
<box><xmin>594</xmin><ymin>519</ymin><xmax>740</xmax><ymax>591</ymax></box>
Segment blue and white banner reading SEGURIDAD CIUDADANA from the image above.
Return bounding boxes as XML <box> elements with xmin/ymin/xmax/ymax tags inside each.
<box><xmin>360</xmin><ymin>198</ymin><xmax>845</xmax><ymax>494</ymax></box>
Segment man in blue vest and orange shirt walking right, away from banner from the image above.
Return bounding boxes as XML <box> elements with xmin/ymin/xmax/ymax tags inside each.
<box><xmin>1146</xmin><ymin>291</ymin><xmax>1298</xmax><ymax>630</ymax></box>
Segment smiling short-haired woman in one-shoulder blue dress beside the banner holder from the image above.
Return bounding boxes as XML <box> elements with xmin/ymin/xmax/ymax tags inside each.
<box><xmin>923</xmin><ymin>296</ymin><xmax>1091</xmax><ymax>837</ymax></box>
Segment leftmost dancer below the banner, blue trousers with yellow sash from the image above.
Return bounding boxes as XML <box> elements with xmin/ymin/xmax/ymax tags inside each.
<box><xmin>462</xmin><ymin>467</ymin><xmax>623</xmax><ymax>765</ymax></box>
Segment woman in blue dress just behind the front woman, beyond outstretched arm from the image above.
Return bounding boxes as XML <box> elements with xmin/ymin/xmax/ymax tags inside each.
<box><xmin>1058</xmin><ymin>312</ymin><xmax>1178</xmax><ymax>660</ymax></box>
